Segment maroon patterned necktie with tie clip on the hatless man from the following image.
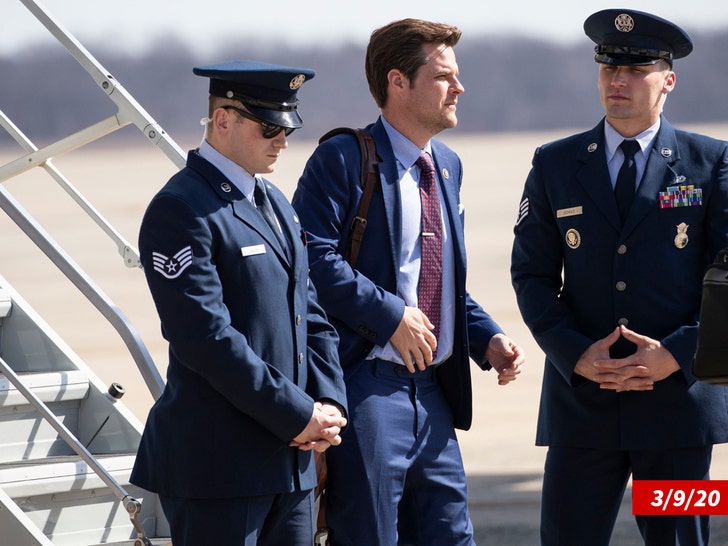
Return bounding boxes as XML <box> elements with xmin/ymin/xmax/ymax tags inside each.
<box><xmin>416</xmin><ymin>153</ymin><xmax>442</xmax><ymax>346</ymax></box>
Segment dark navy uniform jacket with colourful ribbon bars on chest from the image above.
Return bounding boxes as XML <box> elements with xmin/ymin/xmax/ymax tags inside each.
<box><xmin>511</xmin><ymin>118</ymin><xmax>728</xmax><ymax>449</ymax></box>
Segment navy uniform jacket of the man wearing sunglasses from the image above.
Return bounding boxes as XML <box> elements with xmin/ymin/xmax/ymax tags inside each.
<box><xmin>131</xmin><ymin>151</ymin><xmax>346</xmax><ymax>498</ymax></box>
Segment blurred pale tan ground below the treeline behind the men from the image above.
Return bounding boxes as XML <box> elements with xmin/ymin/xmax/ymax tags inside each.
<box><xmin>0</xmin><ymin>126</ymin><xmax>728</xmax><ymax>546</ymax></box>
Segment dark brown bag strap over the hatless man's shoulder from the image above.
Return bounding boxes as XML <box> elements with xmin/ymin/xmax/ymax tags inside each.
<box><xmin>319</xmin><ymin>127</ymin><xmax>380</xmax><ymax>268</ymax></box>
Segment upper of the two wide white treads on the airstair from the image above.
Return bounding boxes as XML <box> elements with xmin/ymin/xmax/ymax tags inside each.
<box><xmin>0</xmin><ymin>370</ymin><xmax>89</xmax><ymax>408</ymax></box>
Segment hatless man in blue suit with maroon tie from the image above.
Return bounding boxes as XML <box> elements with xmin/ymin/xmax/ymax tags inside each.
<box><xmin>292</xmin><ymin>19</ymin><xmax>523</xmax><ymax>546</ymax></box>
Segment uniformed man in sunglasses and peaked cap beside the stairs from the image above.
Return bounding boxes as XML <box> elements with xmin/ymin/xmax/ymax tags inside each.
<box><xmin>131</xmin><ymin>61</ymin><xmax>346</xmax><ymax>546</ymax></box>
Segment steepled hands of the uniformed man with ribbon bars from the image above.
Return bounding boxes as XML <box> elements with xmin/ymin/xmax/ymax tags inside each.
<box><xmin>574</xmin><ymin>326</ymin><xmax>680</xmax><ymax>392</ymax></box>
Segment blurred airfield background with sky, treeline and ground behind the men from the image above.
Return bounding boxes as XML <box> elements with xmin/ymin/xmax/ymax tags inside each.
<box><xmin>0</xmin><ymin>0</ymin><xmax>728</xmax><ymax>546</ymax></box>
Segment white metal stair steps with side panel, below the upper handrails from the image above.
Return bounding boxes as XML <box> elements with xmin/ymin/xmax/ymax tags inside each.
<box><xmin>0</xmin><ymin>277</ymin><xmax>167</xmax><ymax>546</ymax></box>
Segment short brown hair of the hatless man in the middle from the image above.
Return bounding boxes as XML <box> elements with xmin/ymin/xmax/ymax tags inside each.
<box><xmin>365</xmin><ymin>19</ymin><xmax>462</xmax><ymax>108</ymax></box>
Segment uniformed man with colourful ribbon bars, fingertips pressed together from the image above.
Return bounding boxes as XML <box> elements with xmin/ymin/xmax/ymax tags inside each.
<box><xmin>511</xmin><ymin>9</ymin><xmax>728</xmax><ymax>546</ymax></box>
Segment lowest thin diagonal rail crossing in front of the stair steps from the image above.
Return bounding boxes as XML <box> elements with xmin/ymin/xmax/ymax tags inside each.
<box><xmin>0</xmin><ymin>357</ymin><xmax>152</xmax><ymax>546</ymax></box>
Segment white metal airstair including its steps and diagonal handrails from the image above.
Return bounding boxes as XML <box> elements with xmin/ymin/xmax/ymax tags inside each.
<box><xmin>0</xmin><ymin>0</ymin><xmax>184</xmax><ymax>546</ymax></box>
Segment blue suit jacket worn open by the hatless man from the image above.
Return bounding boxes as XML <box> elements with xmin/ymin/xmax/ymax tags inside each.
<box><xmin>292</xmin><ymin>120</ymin><xmax>501</xmax><ymax>429</ymax></box>
